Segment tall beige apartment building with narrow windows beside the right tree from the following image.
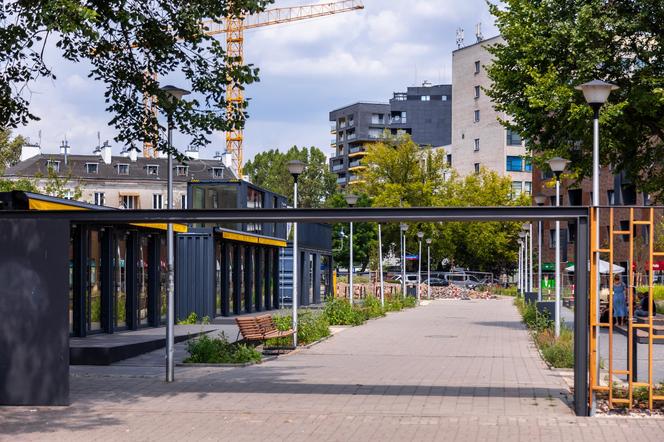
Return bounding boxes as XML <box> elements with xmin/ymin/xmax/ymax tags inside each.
<box><xmin>448</xmin><ymin>36</ymin><xmax>532</xmax><ymax>195</ymax></box>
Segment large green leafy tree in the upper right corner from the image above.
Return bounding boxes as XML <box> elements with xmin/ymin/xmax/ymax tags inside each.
<box><xmin>487</xmin><ymin>0</ymin><xmax>664</xmax><ymax>198</ymax></box>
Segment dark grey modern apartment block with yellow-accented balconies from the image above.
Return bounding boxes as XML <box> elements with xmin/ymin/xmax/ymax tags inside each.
<box><xmin>330</xmin><ymin>83</ymin><xmax>452</xmax><ymax>187</ymax></box>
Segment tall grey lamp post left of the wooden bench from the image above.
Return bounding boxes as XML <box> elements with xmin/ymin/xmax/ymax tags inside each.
<box><xmin>161</xmin><ymin>85</ymin><xmax>190</xmax><ymax>382</ymax></box>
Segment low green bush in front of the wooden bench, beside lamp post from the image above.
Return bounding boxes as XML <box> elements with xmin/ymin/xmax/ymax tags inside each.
<box><xmin>184</xmin><ymin>334</ymin><xmax>261</xmax><ymax>364</ymax></box>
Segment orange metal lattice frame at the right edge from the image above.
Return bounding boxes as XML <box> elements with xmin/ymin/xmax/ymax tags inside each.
<box><xmin>588</xmin><ymin>207</ymin><xmax>664</xmax><ymax>409</ymax></box>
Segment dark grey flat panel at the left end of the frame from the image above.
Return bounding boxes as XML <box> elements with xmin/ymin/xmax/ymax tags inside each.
<box><xmin>0</xmin><ymin>219</ymin><xmax>70</xmax><ymax>405</ymax></box>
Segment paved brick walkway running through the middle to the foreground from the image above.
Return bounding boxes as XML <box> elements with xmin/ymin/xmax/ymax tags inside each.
<box><xmin>0</xmin><ymin>299</ymin><xmax>664</xmax><ymax>441</ymax></box>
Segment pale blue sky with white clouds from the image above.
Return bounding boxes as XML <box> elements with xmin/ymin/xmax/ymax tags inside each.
<box><xmin>15</xmin><ymin>0</ymin><xmax>497</xmax><ymax>160</ymax></box>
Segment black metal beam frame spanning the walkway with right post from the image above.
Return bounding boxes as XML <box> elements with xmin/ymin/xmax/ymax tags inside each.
<box><xmin>0</xmin><ymin>206</ymin><xmax>590</xmax><ymax>416</ymax></box>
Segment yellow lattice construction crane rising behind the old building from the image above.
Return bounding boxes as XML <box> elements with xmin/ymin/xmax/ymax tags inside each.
<box><xmin>143</xmin><ymin>0</ymin><xmax>364</xmax><ymax>178</ymax></box>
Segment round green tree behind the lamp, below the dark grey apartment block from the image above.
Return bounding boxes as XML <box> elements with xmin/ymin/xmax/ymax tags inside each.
<box><xmin>244</xmin><ymin>146</ymin><xmax>336</xmax><ymax>207</ymax></box>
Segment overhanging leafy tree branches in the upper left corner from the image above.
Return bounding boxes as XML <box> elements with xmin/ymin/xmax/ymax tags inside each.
<box><xmin>0</xmin><ymin>0</ymin><xmax>272</xmax><ymax>153</ymax></box>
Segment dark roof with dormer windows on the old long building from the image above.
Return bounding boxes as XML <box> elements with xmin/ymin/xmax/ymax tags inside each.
<box><xmin>5</xmin><ymin>154</ymin><xmax>235</xmax><ymax>182</ymax></box>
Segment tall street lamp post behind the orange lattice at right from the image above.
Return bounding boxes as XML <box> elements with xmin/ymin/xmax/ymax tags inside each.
<box><xmin>576</xmin><ymin>80</ymin><xmax>618</xmax><ymax>404</ymax></box>
